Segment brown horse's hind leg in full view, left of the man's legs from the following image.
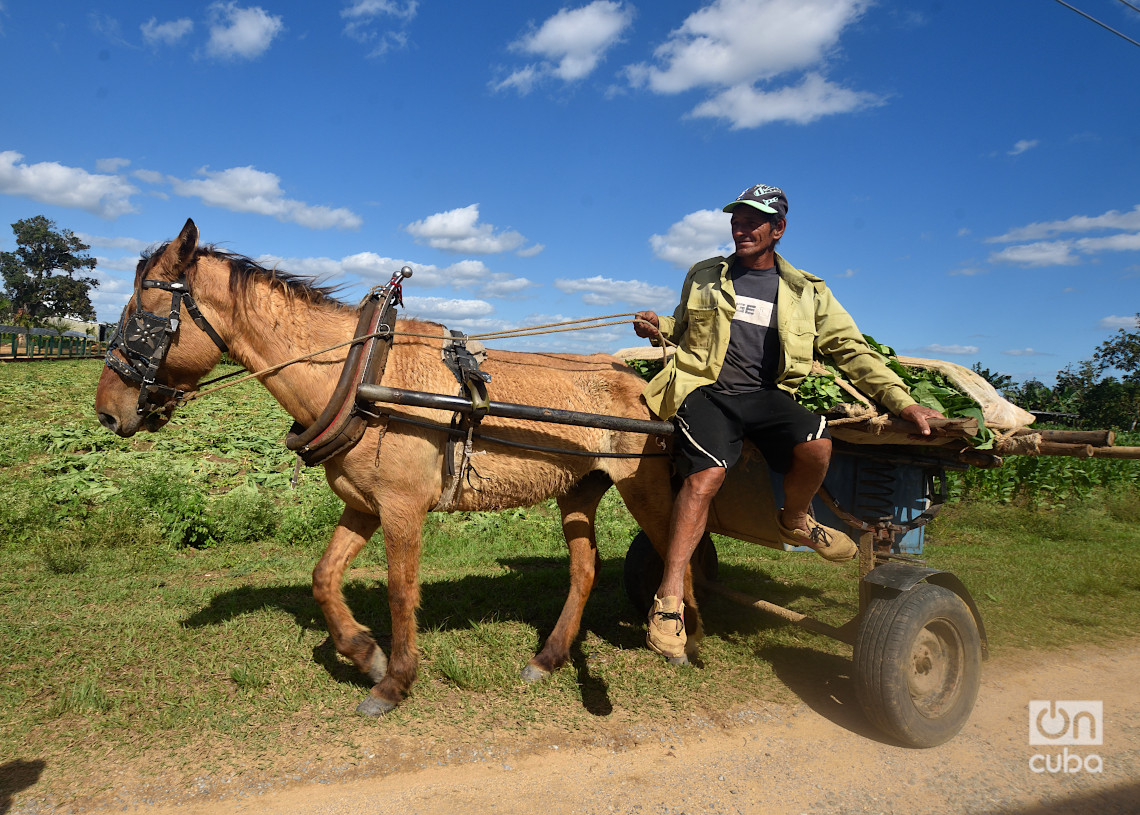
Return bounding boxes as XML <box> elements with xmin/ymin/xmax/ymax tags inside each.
<box><xmin>522</xmin><ymin>471</ymin><xmax>613</xmax><ymax>682</ymax></box>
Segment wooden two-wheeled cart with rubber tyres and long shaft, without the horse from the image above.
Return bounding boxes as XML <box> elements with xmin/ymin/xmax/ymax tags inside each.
<box><xmin>358</xmin><ymin>335</ymin><xmax>1138</xmax><ymax>747</ymax></box>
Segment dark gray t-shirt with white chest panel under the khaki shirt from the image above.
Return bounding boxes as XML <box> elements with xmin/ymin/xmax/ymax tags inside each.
<box><xmin>710</xmin><ymin>263</ymin><xmax>780</xmax><ymax>393</ymax></box>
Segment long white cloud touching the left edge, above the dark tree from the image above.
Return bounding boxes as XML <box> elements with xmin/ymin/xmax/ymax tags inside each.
<box><xmin>0</xmin><ymin>150</ymin><xmax>139</xmax><ymax>220</ymax></box>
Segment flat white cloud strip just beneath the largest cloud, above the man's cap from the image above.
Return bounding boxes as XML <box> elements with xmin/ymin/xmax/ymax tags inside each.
<box><xmin>690</xmin><ymin>73</ymin><xmax>886</xmax><ymax>130</ymax></box>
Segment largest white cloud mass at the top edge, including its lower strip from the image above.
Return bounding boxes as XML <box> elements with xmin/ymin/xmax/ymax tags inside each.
<box><xmin>626</xmin><ymin>0</ymin><xmax>870</xmax><ymax>128</ymax></box>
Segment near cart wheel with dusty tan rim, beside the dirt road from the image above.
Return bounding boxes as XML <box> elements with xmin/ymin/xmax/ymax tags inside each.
<box><xmin>854</xmin><ymin>582</ymin><xmax>982</xmax><ymax>747</ymax></box>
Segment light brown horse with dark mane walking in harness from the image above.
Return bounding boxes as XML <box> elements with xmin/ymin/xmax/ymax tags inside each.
<box><xmin>96</xmin><ymin>221</ymin><xmax>701</xmax><ymax>716</ymax></box>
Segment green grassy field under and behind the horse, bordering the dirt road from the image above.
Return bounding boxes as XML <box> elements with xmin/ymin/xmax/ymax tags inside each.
<box><xmin>0</xmin><ymin>361</ymin><xmax>1140</xmax><ymax>801</ymax></box>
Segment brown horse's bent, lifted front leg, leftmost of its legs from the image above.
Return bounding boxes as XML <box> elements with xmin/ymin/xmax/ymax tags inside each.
<box><xmin>312</xmin><ymin>506</ymin><xmax>388</xmax><ymax>682</ymax></box>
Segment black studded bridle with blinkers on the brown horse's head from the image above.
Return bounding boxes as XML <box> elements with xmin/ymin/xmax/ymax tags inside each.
<box><xmin>104</xmin><ymin>275</ymin><xmax>229</xmax><ymax>416</ymax></box>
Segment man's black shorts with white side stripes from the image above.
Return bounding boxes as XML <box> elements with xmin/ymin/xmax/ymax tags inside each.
<box><xmin>673</xmin><ymin>388</ymin><xmax>831</xmax><ymax>478</ymax></box>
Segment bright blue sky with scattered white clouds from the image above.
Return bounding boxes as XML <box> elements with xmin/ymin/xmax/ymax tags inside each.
<box><xmin>0</xmin><ymin>0</ymin><xmax>1140</xmax><ymax>382</ymax></box>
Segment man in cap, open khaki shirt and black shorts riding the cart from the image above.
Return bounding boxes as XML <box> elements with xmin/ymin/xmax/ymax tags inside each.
<box><xmin>634</xmin><ymin>184</ymin><xmax>942</xmax><ymax>663</ymax></box>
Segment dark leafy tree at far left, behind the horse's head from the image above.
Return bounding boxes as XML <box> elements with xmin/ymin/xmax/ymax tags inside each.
<box><xmin>0</xmin><ymin>215</ymin><xmax>99</xmax><ymax>326</ymax></box>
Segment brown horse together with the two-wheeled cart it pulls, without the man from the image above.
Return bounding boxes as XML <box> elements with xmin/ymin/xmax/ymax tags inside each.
<box><xmin>96</xmin><ymin>226</ymin><xmax>1140</xmax><ymax>745</ymax></box>
